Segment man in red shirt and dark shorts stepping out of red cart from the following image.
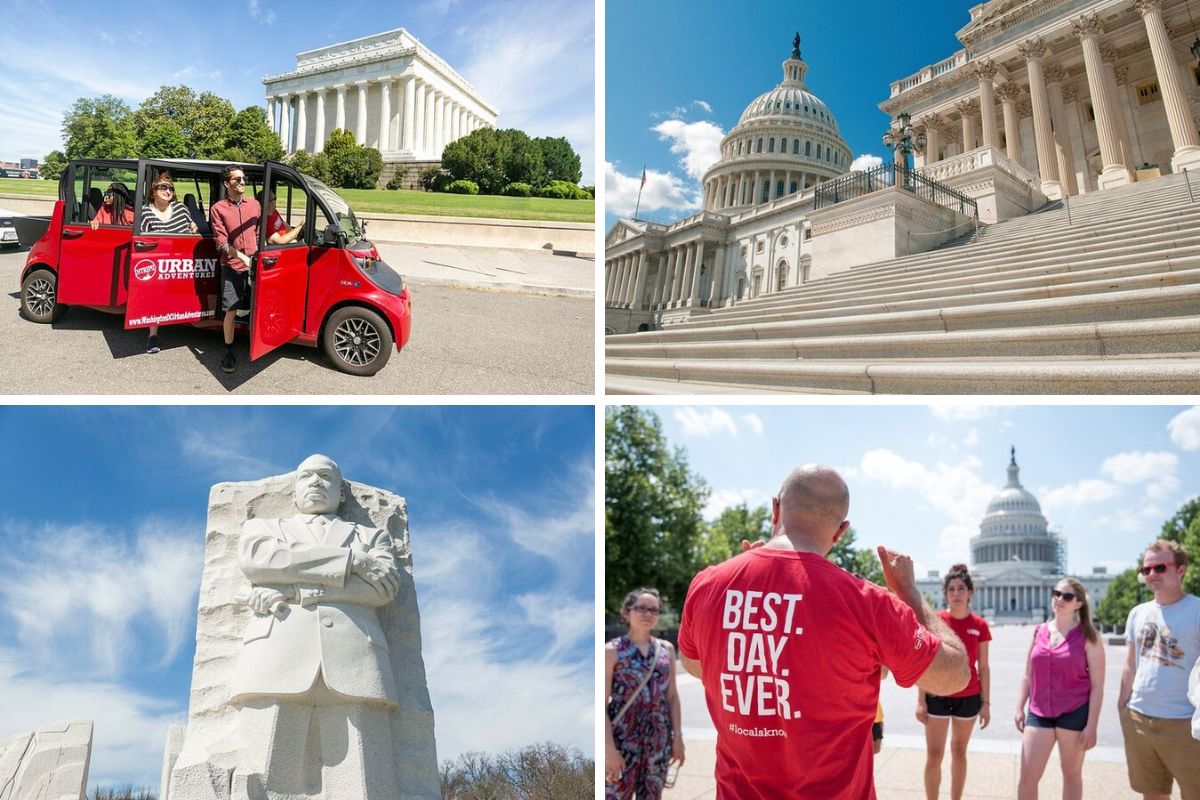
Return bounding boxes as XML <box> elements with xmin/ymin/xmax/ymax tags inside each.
<box><xmin>209</xmin><ymin>164</ymin><xmax>263</xmax><ymax>372</ymax></box>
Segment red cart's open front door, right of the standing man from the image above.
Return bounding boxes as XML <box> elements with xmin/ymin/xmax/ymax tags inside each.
<box><xmin>250</xmin><ymin>161</ymin><xmax>313</xmax><ymax>361</ymax></box>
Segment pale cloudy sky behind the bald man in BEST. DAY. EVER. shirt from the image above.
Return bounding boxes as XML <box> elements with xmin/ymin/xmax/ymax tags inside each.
<box><xmin>633</xmin><ymin>404</ymin><xmax>1200</xmax><ymax>575</ymax></box>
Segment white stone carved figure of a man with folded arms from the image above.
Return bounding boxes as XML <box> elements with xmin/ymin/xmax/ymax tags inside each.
<box><xmin>230</xmin><ymin>455</ymin><xmax>400</xmax><ymax>800</ymax></box>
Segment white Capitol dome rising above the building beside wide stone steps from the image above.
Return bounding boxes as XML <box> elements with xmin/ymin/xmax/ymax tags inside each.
<box><xmin>704</xmin><ymin>34</ymin><xmax>852</xmax><ymax>211</ymax></box>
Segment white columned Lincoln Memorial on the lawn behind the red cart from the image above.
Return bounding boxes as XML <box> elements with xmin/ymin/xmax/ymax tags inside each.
<box><xmin>263</xmin><ymin>28</ymin><xmax>499</xmax><ymax>173</ymax></box>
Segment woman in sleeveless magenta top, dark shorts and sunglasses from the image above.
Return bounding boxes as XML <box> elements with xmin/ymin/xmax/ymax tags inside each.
<box><xmin>1014</xmin><ymin>578</ymin><xmax>1104</xmax><ymax>800</ymax></box>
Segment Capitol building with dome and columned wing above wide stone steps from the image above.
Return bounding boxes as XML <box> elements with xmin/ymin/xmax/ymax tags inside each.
<box><xmin>604</xmin><ymin>0</ymin><xmax>1200</xmax><ymax>333</ymax></box>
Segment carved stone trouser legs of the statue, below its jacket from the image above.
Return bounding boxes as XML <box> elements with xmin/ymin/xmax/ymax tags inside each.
<box><xmin>232</xmin><ymin>674</ymin><xmax>400</xmax><ymax>800</ymax></box>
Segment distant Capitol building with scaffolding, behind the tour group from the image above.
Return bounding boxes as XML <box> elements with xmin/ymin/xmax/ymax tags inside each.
<box><xmin>917</xmin><ymin>450</ymin><xmax>1112</xmax><ymax>622</ymax></box>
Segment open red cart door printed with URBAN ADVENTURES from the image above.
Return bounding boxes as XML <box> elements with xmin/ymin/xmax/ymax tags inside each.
<box><xmin>125</xmin><ymin>161</ymin><xmax>221</xmax><ymax>329</ymax></box>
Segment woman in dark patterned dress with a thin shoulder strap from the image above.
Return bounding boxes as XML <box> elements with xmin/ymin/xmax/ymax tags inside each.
<box><xmin>604</xmin><ymin>589</ymin><xmax>684</xmax><ymax>800</ymax></box>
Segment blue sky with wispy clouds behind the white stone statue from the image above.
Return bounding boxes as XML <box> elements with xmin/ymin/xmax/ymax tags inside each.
<box><xmin>0</xmin><ymin>405</ymin><xmax>595</xmax><ymax>792</ymax></box>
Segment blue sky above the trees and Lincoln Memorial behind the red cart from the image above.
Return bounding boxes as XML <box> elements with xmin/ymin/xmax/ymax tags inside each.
<box><xmin>0</xmin><ymin>0</ymin><xmax>596</xmax><ymax>184</ymax></box>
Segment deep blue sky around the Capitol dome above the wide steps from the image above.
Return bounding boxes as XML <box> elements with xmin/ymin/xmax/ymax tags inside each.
<box><xmin>605</xmin><ymin>0</ymin><xmax>974</xmax><ymax>228</ymax></box>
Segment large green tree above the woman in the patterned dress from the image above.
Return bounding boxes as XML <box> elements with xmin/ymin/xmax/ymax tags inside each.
<box><xmin>604</xmin><ymin>407</ymin><xmax>708</xmax><ymax>613</ymax></box>
